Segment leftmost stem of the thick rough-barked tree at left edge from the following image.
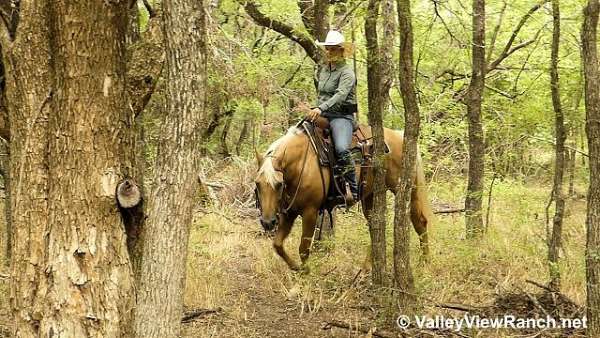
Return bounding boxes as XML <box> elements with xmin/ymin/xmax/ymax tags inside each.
<box><xmin>2</xmin><ymin>5</ymin><xmax>51</xmax><ymax>337</ymax></box>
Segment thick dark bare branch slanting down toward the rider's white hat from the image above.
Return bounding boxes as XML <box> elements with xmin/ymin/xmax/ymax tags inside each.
<box><xmin>243</xmin><ymin>1</ymin><xmax>323</xmax><ymax>63</ymax></box>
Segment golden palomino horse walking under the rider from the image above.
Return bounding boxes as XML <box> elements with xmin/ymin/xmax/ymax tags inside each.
<box><xmin>255</xmin><ymin>127</ymin><xmax>433</xmax><ymax>270</ymax></box>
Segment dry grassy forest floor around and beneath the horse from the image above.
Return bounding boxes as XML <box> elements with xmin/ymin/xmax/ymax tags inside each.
<box><xmin>0</xmin><ymin>168</ymin><xmax>586</xmax><ymax>338</ymax></box>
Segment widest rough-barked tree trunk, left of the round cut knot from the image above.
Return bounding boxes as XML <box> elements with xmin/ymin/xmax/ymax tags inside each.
<box><xmin>2</xmin><ymin>1</ymin><xmax>134</xmax><ymax>337</ymax></box>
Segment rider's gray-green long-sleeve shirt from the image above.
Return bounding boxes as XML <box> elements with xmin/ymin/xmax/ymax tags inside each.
<box><xmin>317</xmin><ymin>60</ymin><xmax>356</xmax><ymax>119</ymax></box>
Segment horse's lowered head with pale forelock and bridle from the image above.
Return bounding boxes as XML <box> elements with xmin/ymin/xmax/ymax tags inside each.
<box><xmin>254</xmin><ymin>153</ymin><xmax>284</xmax><ymax>231</ymax></box>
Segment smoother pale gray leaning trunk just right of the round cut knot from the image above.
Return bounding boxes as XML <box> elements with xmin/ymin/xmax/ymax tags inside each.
<box><xmin>134</xmin><ymin>0</ymin><xmax>207</xmax><ymax>338</ymax></box>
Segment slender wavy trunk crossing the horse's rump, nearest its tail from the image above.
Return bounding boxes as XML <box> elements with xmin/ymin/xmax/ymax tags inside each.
<box><xmin>394</xmin><ymin>0</ymin><xmax>420</xmax><ymax>309</ymax></box>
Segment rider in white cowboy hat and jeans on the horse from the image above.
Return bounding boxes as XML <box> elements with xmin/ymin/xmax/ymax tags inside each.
<box><xmin>300</xmin><ymin>30</ymin><xmax>358</xmax><ymax>206</ymax></box>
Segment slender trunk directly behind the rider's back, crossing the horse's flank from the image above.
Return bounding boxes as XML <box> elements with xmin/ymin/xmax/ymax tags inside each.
<box><xmin>365</xmin><ymin>0</ymin><xmax>393</xmax><ymax>285</ymax></box>
